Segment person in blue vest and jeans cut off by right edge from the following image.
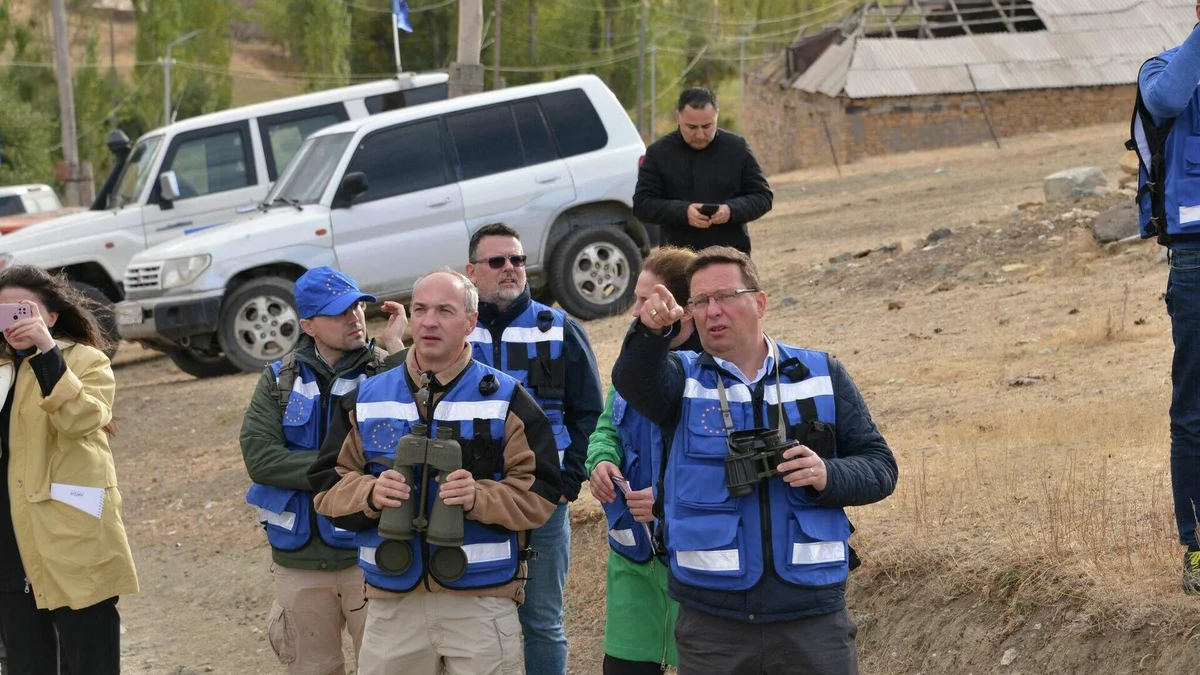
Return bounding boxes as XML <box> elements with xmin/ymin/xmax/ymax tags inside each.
<box><xmin>1130</xmin><ymin>2</ymin><xmax>1200</xmax><ymax>595</ymax></box>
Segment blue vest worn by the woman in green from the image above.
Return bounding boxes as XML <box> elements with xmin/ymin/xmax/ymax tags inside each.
<box><xmin>601</xmin><ymin>394</ymin><xmax>662</xmax><ymax>562</ymax></box>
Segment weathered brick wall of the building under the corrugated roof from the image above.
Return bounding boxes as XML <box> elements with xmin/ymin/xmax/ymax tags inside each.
<box><xmin>744</xmin><ymin>78</ymin><xmax>1134</xmax><ymax>173</ymax></box>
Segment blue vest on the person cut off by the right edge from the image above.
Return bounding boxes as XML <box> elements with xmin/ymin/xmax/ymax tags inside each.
<box><xmin>1133</xmin><ymin>47</ymin><xmax>1200</xmax><ymax>241</ymax></box>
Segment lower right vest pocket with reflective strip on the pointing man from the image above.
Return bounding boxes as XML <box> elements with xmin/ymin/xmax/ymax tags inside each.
<box><xmin>775</xmin><ymin>507</ymin><xmax>850</xmax><ymax>586</ymax></box>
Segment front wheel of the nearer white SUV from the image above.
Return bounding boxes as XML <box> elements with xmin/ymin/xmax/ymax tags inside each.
<box><xmin>217</xmin><ymin>276</ymin><xmax>301</xmax><ymax>372</ymax></box>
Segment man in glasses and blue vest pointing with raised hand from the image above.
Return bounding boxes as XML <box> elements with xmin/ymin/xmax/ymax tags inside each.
<box><xmin>613</xmin><ymin>246</ymin><xmax>898</xmax><ymax>675</ymax></box>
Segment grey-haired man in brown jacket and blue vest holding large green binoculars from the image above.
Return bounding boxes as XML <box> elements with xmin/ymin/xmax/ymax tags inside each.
<box><xmin>308</xmin><ymin>269</ymin><xmax>563</xmax><ymax>675</ymax></box>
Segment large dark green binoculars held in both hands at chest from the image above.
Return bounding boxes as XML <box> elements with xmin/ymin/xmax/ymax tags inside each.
<box><xmin>376</xmin><ymin>423</ymin><xmax>467</xmax><ymax>584</ymax></box>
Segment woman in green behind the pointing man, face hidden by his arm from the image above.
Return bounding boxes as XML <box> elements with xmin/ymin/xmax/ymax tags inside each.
<box><xmin>587</xmin><ymin>246</ymin><xmax>703</xmax><ymax>675</ymax></box>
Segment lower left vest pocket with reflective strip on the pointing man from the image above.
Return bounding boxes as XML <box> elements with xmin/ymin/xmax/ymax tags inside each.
<box><xmin>667</xmin><ymin>513</ymin><xmax>746</xmax><ymax>581</ymax></box>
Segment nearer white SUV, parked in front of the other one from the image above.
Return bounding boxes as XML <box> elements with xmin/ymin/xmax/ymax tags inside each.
<box><xmin>116</xmin><ymin>76</ymin><xmax>652</xmax><ymax>377</ymax></box>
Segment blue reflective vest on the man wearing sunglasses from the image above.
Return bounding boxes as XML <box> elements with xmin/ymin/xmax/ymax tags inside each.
<box><xmin>467</xmin><ymin>300</ymin><xmax>571</xmax><ymax>470</ymax></box>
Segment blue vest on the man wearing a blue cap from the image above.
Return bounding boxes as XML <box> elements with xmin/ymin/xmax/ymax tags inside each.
<box><xmin>246</xmin><ymin>360</ymin><xmax>367</xmax><ymax>551</ymax></box>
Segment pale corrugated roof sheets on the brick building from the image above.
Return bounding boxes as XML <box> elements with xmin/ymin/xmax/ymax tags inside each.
<box><xmin>792</xmin><ymin>0</ymin><xmax>1196</xmax><ymax>98</ymax></box>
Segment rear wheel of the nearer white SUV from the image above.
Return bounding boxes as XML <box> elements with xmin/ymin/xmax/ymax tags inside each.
<box><xmin>550</xmin><ymin>226</ymin><xmax>642</xmax><ymax>321</ymax></box>
